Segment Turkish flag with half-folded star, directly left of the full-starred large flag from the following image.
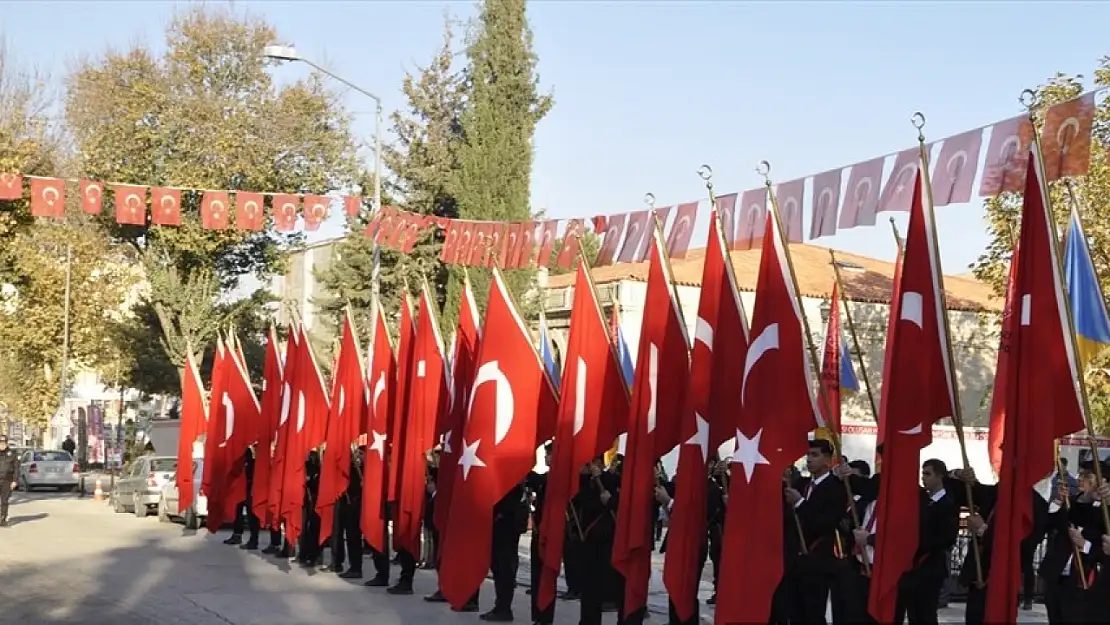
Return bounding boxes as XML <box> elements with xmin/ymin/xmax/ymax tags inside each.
<box><xmin>663</xmin><ymin>211</ymin><xmax>748</xmax><ymax>621</ymax></box>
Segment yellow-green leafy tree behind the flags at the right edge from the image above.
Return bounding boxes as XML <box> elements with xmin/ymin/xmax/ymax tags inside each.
<box><xmin>971</xmin><ymin>64</ymin><xmax>1110</xmax><ymax>434</ymax></box>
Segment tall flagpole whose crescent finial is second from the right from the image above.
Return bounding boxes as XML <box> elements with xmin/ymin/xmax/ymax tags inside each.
<box><xmin>914</xmin><ymin>111</ymin><xmax>983</xmax><ymax>588</ymax></box>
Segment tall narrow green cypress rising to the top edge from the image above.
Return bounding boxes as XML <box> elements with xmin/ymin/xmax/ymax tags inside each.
<box><xmin>445</xmin><ymin>0</ymin><xmax>554</xmax><ymax>321</ymax></box>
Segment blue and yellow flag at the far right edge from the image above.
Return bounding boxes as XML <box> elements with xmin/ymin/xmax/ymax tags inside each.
<box><xmin>1063</xmin><ymin>211</ymin><xmax>1110</xmax><ymax>370</ymax></box>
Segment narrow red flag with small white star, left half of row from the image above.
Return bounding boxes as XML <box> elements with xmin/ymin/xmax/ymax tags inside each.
<box><xmin>362</xmin><ymin>305</ymin><xmax>397</xmax><ymax>553</ymax></box>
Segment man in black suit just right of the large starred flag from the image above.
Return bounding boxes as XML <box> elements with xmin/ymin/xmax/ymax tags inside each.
<box><xmin>785</xmin><ymin>438</ymin><xmax>848</xmax><ymax>624</ymax></box>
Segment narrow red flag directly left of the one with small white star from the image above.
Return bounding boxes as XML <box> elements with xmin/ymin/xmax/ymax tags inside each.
<box><xmin>316</xmin><ymin>310</ymin><xmax>366</xmax><ymax>543</ymax></box>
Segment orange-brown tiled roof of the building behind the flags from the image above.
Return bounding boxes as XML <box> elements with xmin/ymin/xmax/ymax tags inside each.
<box><xmin>547</xmin><ymin>243</ymin><xmax>1002</xmax><ymax>312</ymax></box>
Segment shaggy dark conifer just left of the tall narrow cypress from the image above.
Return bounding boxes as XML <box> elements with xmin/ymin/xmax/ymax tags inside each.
<box><xmin>317</xmin><ymin>19</ymin><xmax>464</xmax><ymax>332</ymax></box>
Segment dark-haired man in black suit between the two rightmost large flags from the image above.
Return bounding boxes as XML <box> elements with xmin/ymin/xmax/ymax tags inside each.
<box><xmin>895</xmin><ymin>458</ymin><xmax>960</xmax><ymax>625</ymax></box>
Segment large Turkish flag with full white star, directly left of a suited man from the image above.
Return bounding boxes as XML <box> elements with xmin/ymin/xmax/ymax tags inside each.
<box><xmin>716</xmin><ymin>211</ymin><xmax>820</xmax><ymax>625</ymax></box>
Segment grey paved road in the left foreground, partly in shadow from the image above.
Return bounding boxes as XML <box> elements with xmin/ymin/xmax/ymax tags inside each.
<box><xmin>0</xmin><ymin>493</ymin><xmax>1045</xmax><ymax>625</ymax></box>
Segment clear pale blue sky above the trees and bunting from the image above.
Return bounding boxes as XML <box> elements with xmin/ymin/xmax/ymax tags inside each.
<box><xmin>0</xmin><ymin>0</ymin><xmax>1110</xmax><ymax>273</ymax></box>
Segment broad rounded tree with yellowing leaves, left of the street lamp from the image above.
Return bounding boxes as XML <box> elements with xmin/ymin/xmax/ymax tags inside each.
<box><xmin>65</xmin><ymin>7</ymin><xmax>355</xmax><ymax>390</ymax></box>
